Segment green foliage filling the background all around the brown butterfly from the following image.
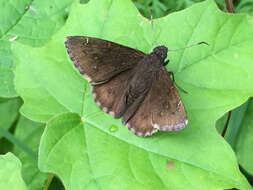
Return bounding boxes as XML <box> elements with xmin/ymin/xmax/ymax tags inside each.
<box><xmin>0</xmin><ymin>0</ymin><xmax>253</xmax><ymax>190</ymax></box>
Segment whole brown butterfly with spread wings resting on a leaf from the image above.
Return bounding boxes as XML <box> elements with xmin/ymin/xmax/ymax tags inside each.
<box><xmin>65</xmin><ymin>36</ymin><xmax>187</xmax><ymax>136</ymax></box>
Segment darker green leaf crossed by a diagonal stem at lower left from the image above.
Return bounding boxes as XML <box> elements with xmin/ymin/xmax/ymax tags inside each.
<box><xmin>14</xmin><ymin>116</ymin><xmax>48</xmax><ymax>190</ymax></box>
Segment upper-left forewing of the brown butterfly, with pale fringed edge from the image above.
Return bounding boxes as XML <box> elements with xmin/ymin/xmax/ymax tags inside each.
<box><xmin>65</xmin><ymin>36</ymin><xmax>145</xmax><ymax>84</ymax></box>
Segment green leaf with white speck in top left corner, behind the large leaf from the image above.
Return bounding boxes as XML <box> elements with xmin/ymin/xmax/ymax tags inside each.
<box><xmin>0</xmin><ymin>0</ymin><xmax>72</xmax><ymax>97</ymax></box>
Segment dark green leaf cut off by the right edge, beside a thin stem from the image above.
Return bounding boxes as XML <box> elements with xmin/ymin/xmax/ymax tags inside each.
<box><xmin>235</xmin><ymin>99</ymin><xmax>253</xmax><ymax>175</ymax></box>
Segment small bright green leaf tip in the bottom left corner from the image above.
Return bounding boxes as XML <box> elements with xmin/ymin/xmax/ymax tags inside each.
<box><xmin>0</xmin><ymin>153</ymin><xmax>27</xmax><ymax>190</ymax></box>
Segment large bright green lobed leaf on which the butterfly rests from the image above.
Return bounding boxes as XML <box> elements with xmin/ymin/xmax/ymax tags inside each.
<box><xmin>13</xmin><ymin>0</ymin><xmax>253</xmax><ymax>189</ymax></box>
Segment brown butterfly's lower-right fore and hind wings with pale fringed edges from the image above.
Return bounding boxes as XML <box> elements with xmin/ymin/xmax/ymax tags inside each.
<box><xmin>126</xmin><ymin>68</ymin><xmax>187</xmax><ymax>136</ymax></box>
